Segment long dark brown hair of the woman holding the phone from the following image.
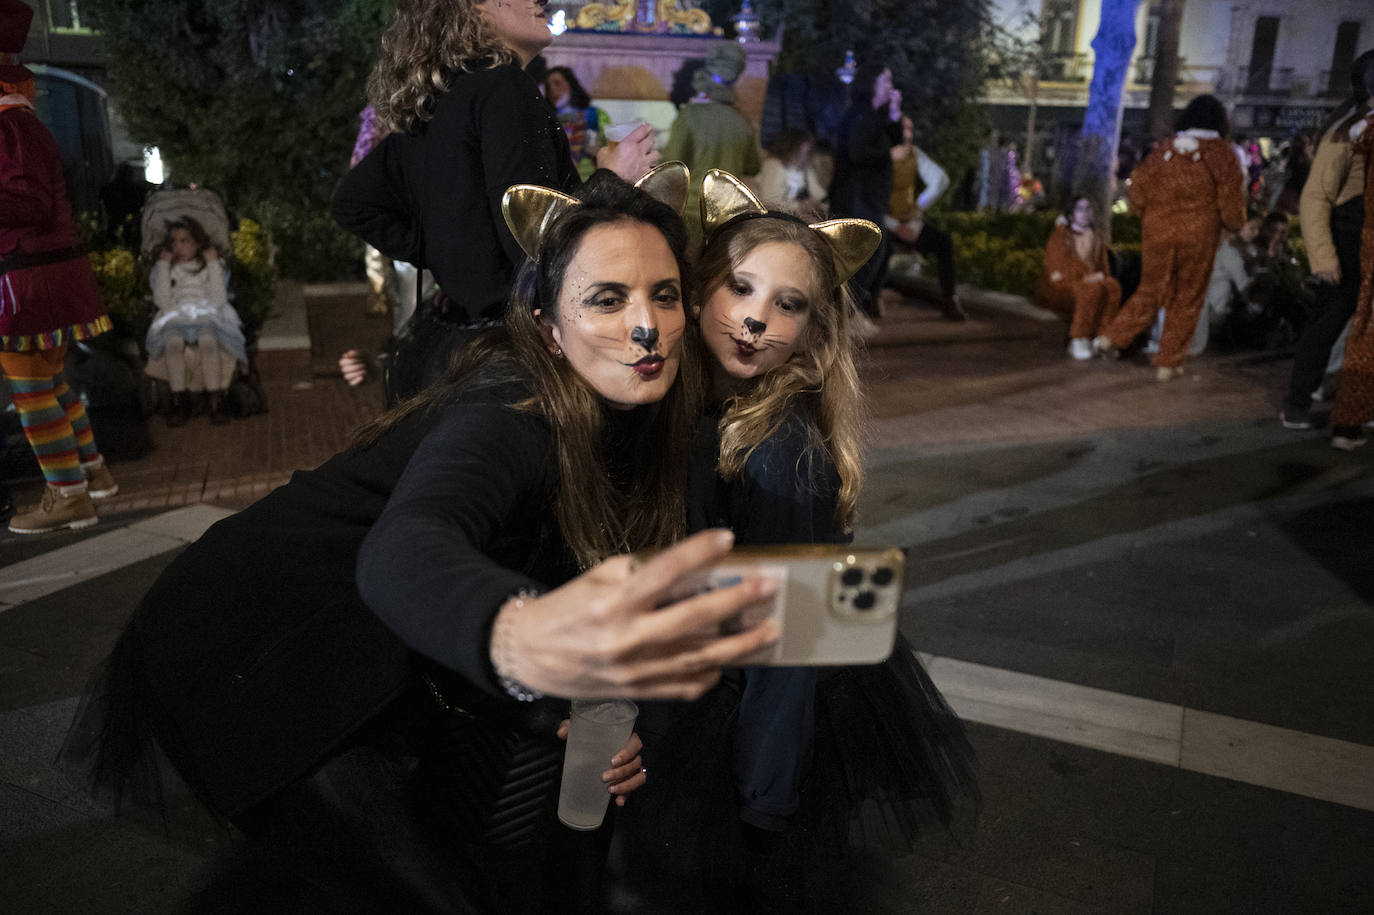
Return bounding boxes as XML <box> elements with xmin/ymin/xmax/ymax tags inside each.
<box><xmin>354</xmin><ymin>172</ymin><xmax>702</xmax><ymax>569</ymax></box>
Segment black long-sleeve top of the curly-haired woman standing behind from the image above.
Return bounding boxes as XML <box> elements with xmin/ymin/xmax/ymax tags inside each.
<box><xmin>333</xmin><ymin>63</ymin><xmax>581</xmax><ymax>323</ymax></box>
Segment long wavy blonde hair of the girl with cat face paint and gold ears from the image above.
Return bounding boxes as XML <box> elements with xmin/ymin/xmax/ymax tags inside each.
<box><xmin>692</xmin><ymin>216</ymin><xmax>866</xmax><ymax>530</ymax></box>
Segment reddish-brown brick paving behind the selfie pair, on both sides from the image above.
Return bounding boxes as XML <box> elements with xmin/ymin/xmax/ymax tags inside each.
<box><xmin>5</xmin><ymin>291</ymin><xmax>1289</xmax><ymax>515</ymax></box>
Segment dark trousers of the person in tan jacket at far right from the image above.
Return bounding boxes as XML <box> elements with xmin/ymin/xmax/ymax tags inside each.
<box><xmin>1283</xmin><ymin>196</ymin><xmax>1364</xmax><ymax>416</ymax></box>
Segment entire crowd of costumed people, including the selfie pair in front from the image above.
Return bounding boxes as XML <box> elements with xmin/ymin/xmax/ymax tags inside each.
<box><xmin>0</xmin><ymin>0</ymin><xmax>1374</xmax><ymax>912</ymax></box>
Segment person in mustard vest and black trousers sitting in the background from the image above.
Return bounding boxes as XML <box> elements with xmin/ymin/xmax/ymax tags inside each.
<box><xmin>882</xmin><ymin>115</ymin><xmax>969</xmax><ymax>321</ymax></box>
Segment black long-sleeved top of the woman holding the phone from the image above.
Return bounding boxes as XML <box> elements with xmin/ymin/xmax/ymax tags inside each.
<box><xmin>129</xmin><ymin>370</ymin><xmax>576</xmax><ymax>816</ymax></box>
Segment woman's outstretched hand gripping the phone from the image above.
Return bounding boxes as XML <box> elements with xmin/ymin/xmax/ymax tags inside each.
<box><xmin>492</xmin><ymin>530</ymin><xmax>779</xmax><ymax>699</ymax></box>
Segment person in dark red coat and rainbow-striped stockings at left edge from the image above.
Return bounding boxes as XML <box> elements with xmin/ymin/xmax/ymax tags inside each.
<box><xmin>0</xmin><ymin>0</ymin><xmax>120</xmax><ymax>534</ymax></box>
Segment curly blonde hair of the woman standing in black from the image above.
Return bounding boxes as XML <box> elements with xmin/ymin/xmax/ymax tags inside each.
<box><xmin>367</xmin><ymin>0</ymin><xmax>517</xmax><ymax>132</ymax></box>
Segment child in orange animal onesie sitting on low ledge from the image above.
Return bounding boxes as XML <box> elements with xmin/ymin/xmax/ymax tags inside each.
<box><xmin>1035</xmin><ymin>196</ymin><xmax>1121</xmax><ymax>359</ymax></box>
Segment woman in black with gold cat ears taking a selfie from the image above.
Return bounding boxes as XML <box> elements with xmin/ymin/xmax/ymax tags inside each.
<box><xmin>69</xmin><ymin>169</ymin><xmax>776</xmax><ymax>911</ymax></box>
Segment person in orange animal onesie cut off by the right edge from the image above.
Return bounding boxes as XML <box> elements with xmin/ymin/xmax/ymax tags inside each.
<box><xmin>1331</xmin><ymin>105</ymin><xmax>1374</xmax><ymax>451</ymax></box>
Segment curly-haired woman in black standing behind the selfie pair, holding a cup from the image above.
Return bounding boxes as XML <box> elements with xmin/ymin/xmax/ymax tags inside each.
<box><xmin>334</xmin><ymin>0</ymin><xmax>657</xmax><ymax>400</ymax></box>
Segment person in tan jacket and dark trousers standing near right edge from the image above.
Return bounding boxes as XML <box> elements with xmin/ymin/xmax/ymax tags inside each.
<box><xmin>1279</xmin><ymin>51</ymin><xmax>1374</xmax><ymax>429</ymax></box>
